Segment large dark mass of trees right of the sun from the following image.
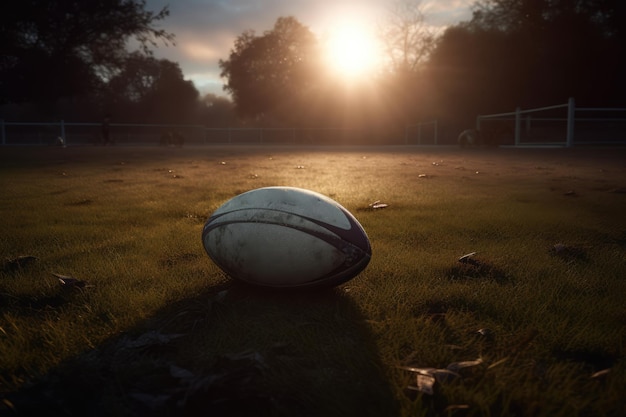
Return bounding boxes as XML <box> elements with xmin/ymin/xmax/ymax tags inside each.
<box><xmin>426</xmin><ymin>0</ymin><xmax>626</xmax><ymax>132</ymax></box>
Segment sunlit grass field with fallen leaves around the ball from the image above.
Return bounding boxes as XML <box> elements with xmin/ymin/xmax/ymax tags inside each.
<box><xmin>0</xmin><ymin>147</ymin><xmax>626</xmax><ymax>417</ymax></box>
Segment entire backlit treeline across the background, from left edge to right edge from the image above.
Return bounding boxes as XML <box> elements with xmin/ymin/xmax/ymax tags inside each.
<box><xmin>0</xmin><ymin>0</ymin><xmax>626</xmax><ymax>141</ymax></box>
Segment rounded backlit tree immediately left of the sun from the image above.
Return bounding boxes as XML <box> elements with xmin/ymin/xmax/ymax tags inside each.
<box><xmin>219</xmin><ymin>17</ymin><xmax>320</xmax><ymax>119</ymax></box>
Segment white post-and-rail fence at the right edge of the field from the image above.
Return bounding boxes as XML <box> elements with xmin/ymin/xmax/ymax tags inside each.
<box><xmin>476</xmin><ymin>98</ymin><xmax>626</xmax><ymax>147</ymax></box>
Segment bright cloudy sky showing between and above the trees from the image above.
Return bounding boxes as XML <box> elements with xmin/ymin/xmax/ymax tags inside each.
<box><xmin>146</xmin><ymin>0</ymin><xmax>473</xmax><ymax>95</ymax></box>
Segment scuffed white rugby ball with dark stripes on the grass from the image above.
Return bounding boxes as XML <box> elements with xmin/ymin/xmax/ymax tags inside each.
<box><xmin>202</xmin><ymin>187</ymin><xmax>372</xmax><ymax>288</ymax></box>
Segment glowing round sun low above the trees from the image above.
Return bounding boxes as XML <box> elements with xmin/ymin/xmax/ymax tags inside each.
<box><xmin>324</xmin><ymin>25</ymin><xmax>382</xmax><ymax>79</ymax></box>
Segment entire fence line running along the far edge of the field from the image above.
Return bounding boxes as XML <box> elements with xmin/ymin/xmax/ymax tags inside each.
<box><xmin>0</xmin><ymin>102</ymin><xmax>626</xmax><ymax>147</ymax></box>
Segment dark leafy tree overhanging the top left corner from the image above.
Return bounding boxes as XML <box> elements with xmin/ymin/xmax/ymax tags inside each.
<box><xmin>0</xmin><ymin>0</ymin><xmax>173</xmax><ymax>102</ymax></box>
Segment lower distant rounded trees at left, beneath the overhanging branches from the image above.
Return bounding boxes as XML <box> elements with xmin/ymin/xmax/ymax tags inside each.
<box><xmin>0</xmin><ymin>54</ymin><xmax>237</xmax><ymax>127</ymax></box>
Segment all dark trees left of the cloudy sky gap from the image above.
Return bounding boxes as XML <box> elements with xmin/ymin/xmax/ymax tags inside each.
<box><xmin>0</xmin><ymin>0</ymin><xmax>234</xmax><ymax>127</ymax></box>
